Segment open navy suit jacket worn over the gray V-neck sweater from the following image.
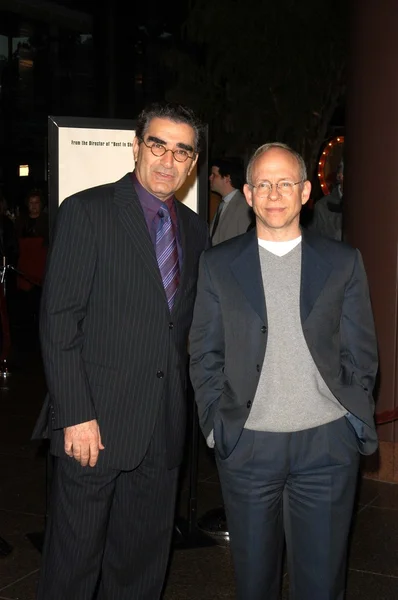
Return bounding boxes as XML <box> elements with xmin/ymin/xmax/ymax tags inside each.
<box><xmin>190</xmin><ymin>230</ymin><xmax>378</xmax><ymax>457</ymax></box>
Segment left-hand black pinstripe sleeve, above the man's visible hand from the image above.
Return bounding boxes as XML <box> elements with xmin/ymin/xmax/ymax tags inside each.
<box><xmin>40</xmin><ymin>197</ymin><xmax>97</xmax><ymax>429</ymax></box>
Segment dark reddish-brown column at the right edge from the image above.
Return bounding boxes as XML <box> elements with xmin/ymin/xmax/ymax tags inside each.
<box><xmin>344</xmin><ymin>0</ymin><xmax>398</xmax><ymax>482</ymax></box>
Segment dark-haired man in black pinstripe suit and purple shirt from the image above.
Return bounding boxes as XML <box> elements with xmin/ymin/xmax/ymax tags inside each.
<box><xmin>33</xmin><ymin>104</ymin><xmax>208</xmax><ymax>600</ymax></box>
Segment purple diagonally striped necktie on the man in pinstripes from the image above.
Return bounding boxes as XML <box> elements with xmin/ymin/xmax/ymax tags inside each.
<box><xmin>156</xmin><ymin>206</ymin><xmax>180</xmax><ymax>311</ymax></box>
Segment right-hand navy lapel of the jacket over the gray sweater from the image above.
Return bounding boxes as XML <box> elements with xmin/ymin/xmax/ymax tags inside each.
<box><xmin>300</xmin><ymin>231</ymin><xmax>333</xmax><ymax>324</ymax></box>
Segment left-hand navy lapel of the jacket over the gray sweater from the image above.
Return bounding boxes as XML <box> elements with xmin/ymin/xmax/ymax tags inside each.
<box><xmin>231</xmin><ymin>229</ymin><xmax>266</xmax><ymax>323</ymax></box>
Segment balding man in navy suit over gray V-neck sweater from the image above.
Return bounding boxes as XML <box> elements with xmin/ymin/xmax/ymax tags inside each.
<box><xmin>190</xmin><ymin>143</ymin><xmax>378</xmax><ymax>600</ymax></box>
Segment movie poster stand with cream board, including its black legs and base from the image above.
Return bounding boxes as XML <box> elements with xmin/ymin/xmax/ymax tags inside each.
<box><xmin>27</xmin><ymin>116</ymin><xmax>215</xmax><ymax>551</ymax></box>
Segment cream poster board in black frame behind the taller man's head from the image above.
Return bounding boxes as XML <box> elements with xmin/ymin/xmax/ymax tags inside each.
<box><xmin>48</xmin><ymin>116</ymin><xmax>208</xmax><ymax>231</ymax></box>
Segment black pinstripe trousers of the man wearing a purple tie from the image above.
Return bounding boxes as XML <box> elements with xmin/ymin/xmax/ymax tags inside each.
<box><xmin>37</xmin><ymin>412</ymin><xmax>179</xmax><ymax>600</ymax></box>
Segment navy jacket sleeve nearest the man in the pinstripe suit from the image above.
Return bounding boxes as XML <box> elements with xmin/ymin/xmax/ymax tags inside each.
<box><xmin>189</xmin><ymin>253</ymin><xmax>224</xmax><ymax>439</ymax></box>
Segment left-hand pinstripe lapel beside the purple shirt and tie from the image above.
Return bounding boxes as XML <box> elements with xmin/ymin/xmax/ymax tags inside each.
<box><xmin>114</xmin><ymin>174</ymin><xmax>166</xmax><ymax>301</ymax></box>
